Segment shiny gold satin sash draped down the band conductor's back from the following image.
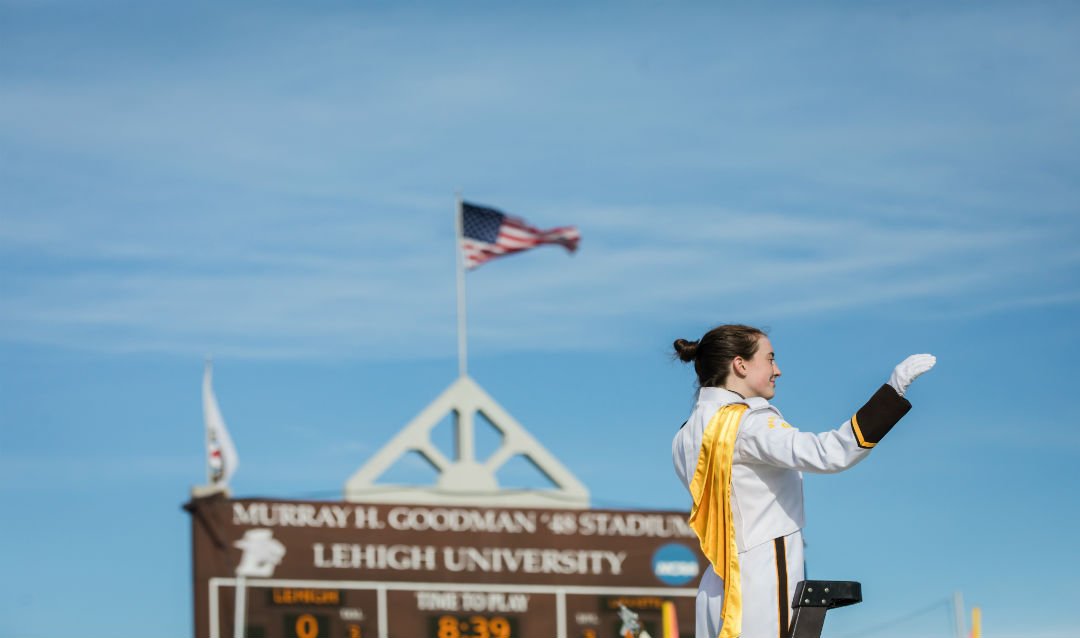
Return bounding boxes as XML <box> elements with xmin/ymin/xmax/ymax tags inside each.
<box><xmin>689</xmin><ymin>404</ymin><xmax>746</xmax><ymax>638</ymax></box>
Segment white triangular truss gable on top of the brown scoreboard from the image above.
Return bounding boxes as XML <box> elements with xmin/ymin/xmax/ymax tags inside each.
<box><xmin>345</xmin><ymin>376</ymin><xmax>589</xmax><ymax>508</ymax></box>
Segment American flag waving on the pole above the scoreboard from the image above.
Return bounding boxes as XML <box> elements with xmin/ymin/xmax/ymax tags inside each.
<box><xmin>461</xmin><ymin>202</ymin><xmax>581</xmax><ymax>270</ymax></box>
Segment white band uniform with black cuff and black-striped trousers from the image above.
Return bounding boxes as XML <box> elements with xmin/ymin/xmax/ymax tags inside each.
<box><xmin>672</xmin><ymin>385</ymin><xmax>910</xmax><ymax>638</ymax></box>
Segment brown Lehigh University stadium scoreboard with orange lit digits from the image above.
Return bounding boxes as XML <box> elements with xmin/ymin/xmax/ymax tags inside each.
<box><xmin>186</xmin><ymin>493</ymin><xmax>708</xmax><ymax>638</ymax></box>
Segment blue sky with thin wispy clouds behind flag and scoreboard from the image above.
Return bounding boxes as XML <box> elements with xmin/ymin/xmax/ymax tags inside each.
<box><xmin>0</xmin><ymin>0</ymin><xmax>1080</xmax><ymax>637</ymax></box>
